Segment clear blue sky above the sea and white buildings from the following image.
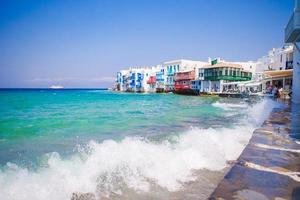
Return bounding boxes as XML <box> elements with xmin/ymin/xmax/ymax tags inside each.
<box><xmin>0</xmin><ymin>0</ymin><xmax>294</xmax><ymax>88</ymax></box>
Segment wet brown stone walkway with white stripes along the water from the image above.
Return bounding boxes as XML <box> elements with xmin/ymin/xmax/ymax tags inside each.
<box><xmin>209</xmin><ymin>105</ymin><xmax>300</xmax><ymax>200</ymax></box>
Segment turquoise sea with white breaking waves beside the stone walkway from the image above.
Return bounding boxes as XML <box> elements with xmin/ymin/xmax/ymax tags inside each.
<box><xmin>0</xmin><ymin>89</ymin><xmax>276</xmax><ymax>200</ymax></box>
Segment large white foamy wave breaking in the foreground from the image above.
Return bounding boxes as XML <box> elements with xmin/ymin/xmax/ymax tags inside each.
<box><xmin>0</xmin><ymin>99</ymin><xmax>282</xmax><ymax>200</ymax></box>
